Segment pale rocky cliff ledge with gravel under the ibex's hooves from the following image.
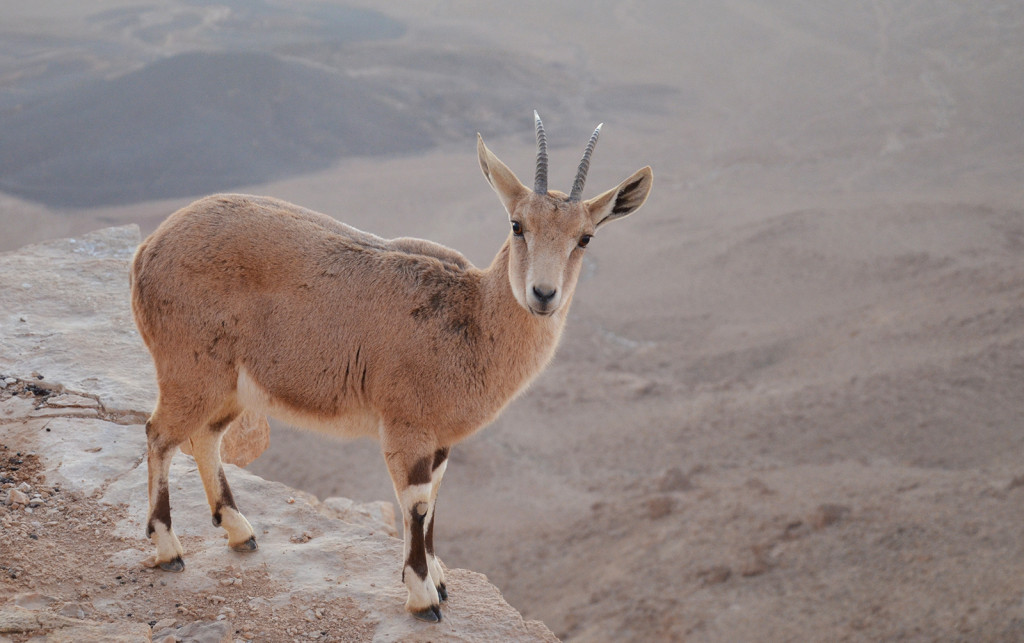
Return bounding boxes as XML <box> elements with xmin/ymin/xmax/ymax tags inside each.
<box><xmin>0</xmin><ymin>226</ymin><xmax>556</xmax><ymax>642</ymax></box>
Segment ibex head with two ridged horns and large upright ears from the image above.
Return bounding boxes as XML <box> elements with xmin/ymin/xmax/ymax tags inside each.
<box><xmin>476</xmin><ymin>112</ymin><xmax>653</xmax><ymax>315</ymax></box>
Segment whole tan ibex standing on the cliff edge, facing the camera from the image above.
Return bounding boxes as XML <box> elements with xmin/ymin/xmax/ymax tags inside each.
<box><xmin>131</xmin><ymin>112</ymin><xmax>652</xmax><ymax>621</ymax></box>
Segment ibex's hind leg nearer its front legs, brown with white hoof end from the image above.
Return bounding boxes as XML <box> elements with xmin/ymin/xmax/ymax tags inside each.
<box><xmin>188</xmin><ymin>411</ymin><xmax>257</xmax><ymax>552</ymax></box>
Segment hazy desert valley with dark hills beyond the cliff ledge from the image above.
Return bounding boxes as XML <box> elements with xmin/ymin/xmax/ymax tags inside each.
<box><xmin>0</xmin><ymin>0</ymin><xmax>1024</xmax><ymax>641</ymax></box>
